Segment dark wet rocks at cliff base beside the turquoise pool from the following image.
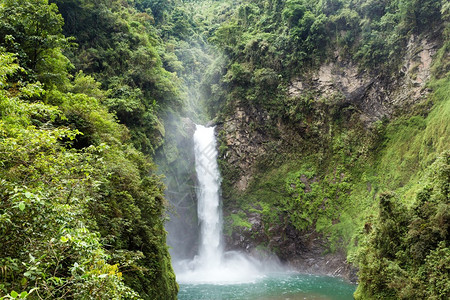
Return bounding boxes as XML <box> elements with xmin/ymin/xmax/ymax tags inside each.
<box><xmin>226</xmin><ymin>213</ymin><xmax>357</xmax><ymax>282</ymax></box>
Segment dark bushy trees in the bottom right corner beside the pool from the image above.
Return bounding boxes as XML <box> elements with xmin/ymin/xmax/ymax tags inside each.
<box><xmin>355</xmin><ymin>152</ymin><xmax>450</xmax><ymax>299</ymax></box>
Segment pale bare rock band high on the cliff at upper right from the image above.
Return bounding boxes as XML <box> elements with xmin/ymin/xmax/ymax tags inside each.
<box><xmin>289</xmin><ymin>35</ymin><xmax>438</xmax><ymax>125</ymax></box>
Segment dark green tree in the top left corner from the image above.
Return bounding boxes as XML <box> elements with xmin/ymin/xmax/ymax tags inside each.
<box><xmin>0</xmin><ymin>0</ymin><xmax>71</xmax><ymax>87</ymax></box>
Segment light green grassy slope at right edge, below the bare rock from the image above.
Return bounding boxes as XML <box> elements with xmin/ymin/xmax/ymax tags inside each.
<box><xmin>378</xmin><ymin>78</ymin><xmax>450</xmax><ymax>189</ymax></box>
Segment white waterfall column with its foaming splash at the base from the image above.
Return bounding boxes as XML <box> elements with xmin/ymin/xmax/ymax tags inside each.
<box><xmin>174</xmin><ymin>125</ymin><xmax>264</xmax><ymax>284</ymax></box>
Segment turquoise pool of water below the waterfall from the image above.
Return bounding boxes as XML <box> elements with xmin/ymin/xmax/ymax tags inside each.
<box><xmin>178</xmin><ymin>273</ymin><xmax>356</xmax><ymax>300</ymax></box>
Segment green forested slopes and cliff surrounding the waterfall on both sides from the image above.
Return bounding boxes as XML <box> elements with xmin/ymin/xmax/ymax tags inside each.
<box><xmin>0</xmin><ymin>0</ymin><xmax>450</xmax><ymax>299</ymax></box>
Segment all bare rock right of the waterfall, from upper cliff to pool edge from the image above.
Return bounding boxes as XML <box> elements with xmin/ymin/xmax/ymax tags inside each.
<box><xmin>214</xmin><ymin>36</ymin><xmax>438</xmax><ymax>280</ymax></box>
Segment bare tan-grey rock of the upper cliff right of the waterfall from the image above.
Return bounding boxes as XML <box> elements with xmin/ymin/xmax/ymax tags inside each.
<box><xmin>218</xmin><ymin>31</ymin><xmax>438</xmax><ymax>191</ymax></box>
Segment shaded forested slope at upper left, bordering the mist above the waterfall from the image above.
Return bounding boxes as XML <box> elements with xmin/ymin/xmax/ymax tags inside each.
<box><xmin>54</xmin><ymin>0</ymin><xmax>181</xmax><ymax>154</ymax></box>
